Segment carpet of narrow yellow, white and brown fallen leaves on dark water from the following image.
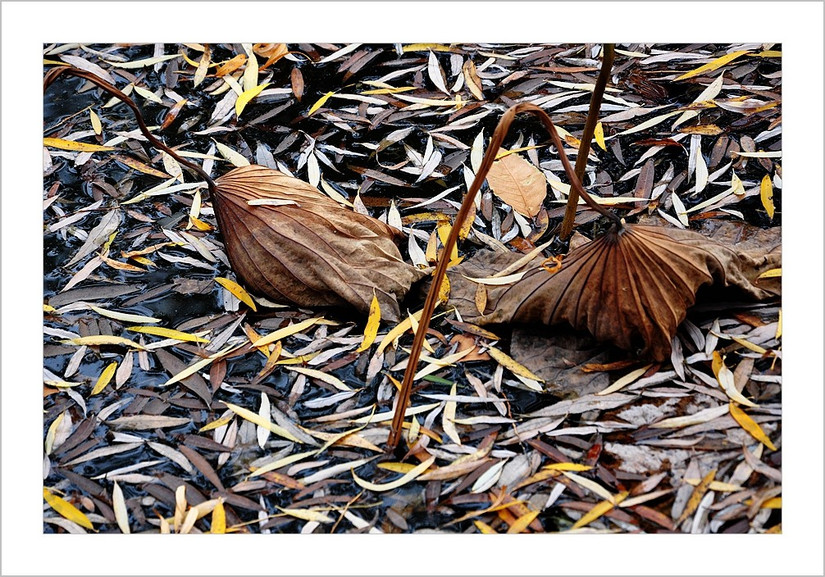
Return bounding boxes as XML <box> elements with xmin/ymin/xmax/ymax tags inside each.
<box><xmin>43</xmin><ymin>44</ymin><xmax>782</xmax><ymax>533</ymax></box>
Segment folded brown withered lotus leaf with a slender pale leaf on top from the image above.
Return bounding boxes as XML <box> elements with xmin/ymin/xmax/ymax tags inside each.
<box><xmin>214</xmin><ymin>165</ymin><xmax>423</xmax><ymax>321</ymax></box>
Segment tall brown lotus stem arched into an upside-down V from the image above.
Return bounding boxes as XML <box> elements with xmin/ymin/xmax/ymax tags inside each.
<box><xmin>387</xmin><ymin>103</ymin><xmax>622</xmax><ymax>450</ymax></box>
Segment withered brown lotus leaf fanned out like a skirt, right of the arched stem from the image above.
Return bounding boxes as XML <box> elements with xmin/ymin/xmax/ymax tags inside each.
<box><xmin>483</xmin><ymin>224</ymin><xmax>781</xmax><ymax>361</ymax></box>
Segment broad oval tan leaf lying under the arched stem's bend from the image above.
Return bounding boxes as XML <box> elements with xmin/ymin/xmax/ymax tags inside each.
<box><xmin>487</xmin><ymin>154</ymin><xmax>547</xmax><ymax>216</ymax></box>
